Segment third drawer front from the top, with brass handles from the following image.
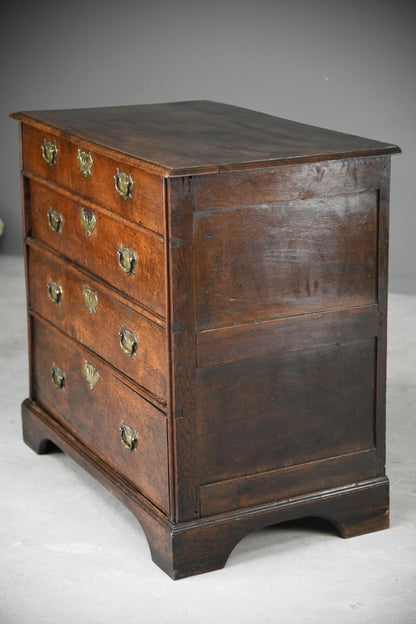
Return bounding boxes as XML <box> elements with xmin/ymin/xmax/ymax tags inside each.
<box><xmin>28</xmin><ymin>244</ymin><xmax>167</xmax><ymax>402</ymax></box>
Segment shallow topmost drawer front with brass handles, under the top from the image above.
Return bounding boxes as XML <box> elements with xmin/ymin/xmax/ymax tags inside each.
<box><xmin>22</xmin><ymin>124</ymin><xmax>164</xmax><ymax>234</ymax></box>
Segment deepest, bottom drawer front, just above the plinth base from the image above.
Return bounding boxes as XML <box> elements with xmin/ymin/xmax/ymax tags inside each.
<box><xmin>32</xmin><ymin>319</ymin><xmax>169</xmax><ymax>511</ymax></box>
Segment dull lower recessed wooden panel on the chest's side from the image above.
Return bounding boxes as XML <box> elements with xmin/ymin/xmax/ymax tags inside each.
<box><xmin>198</xmin><ymin>339</ymin><xmax>376</xmax><ymax>484</ymax></box>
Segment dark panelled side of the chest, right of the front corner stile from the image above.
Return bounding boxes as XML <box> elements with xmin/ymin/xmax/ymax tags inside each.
<box><xmin>192</xmin><ymin>157</ymin><xmax>387</xmax><ymax>515</ymax></box>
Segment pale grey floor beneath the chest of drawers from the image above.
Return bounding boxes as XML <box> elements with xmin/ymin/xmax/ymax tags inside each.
<box><xmin>0</xmin><ymin>255</ymin><xmax>416</xmax><ymax>624</ymax></box>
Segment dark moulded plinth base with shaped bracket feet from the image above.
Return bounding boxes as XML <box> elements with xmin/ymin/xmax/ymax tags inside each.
<box><xmin>22</xmin><ymin>400</ymin><xmax>389</xmax><ymax>580</ymax></box>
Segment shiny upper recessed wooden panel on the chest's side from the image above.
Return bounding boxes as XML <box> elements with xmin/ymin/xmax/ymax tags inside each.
<box><xmin>195</xmin><ymin>191</ymin><xmax>378</xmax><ymax>330</ymax></box>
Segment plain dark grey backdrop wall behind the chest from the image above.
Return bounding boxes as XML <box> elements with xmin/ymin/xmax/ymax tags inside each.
<box><xmin>0</xmin><ymin>0</ymin><xmax>416</xmax><ymax>292</ymax></box>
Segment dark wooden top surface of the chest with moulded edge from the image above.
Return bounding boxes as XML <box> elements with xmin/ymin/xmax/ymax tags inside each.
<box><xmin>11</xmin><ymin>100</ymin><xmax>400</xmax><ymax>176</ymax></box>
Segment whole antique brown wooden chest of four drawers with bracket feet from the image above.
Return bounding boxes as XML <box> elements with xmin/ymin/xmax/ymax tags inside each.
<box><xmin>12</xmin><ymin>101</ymin><xmax>400</xmax><ymax>578</ymax></box>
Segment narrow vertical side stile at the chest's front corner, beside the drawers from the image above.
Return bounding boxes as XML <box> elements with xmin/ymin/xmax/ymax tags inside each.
<box><xmin>167</xmin><ymin>177</ymin><xmax>200</xmax><ymax>522</ymax></box>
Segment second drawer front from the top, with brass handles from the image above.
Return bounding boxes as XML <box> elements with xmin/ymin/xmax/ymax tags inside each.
<box><xmin>30</xmin><ymin>180</ymin><xmax>165</xmax><ymax>316</ymax></box>
